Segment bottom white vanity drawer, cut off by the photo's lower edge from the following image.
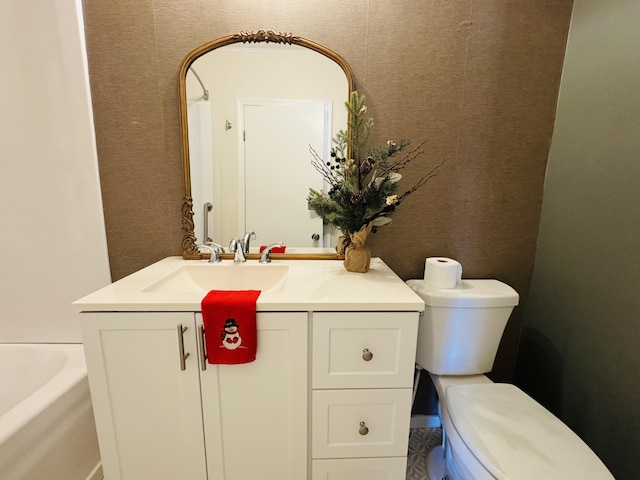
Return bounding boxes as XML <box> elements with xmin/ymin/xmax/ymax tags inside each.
<box><xmin>311</xmin><ymin>457</ymin><xmax>407</xmax><ymax>480</ymax></box>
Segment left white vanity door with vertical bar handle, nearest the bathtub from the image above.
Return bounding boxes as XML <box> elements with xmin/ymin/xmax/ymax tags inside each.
<box><xmin>81</xmin><ymin>313</ymin><xmax>207</xmax><ymax>480</ymax></box>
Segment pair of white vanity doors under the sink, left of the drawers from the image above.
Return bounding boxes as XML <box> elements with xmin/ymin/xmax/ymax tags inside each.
<box><xmin>81</xmin><ymin>312</ymin><xmax>308</xmax><ymax>480</ymax></box>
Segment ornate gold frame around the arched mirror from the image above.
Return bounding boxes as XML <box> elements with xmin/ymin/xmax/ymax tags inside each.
<box><xmin>178</xmin><ymin>30</ymin><xmax>355</xmax><ymax>260</ymax></box>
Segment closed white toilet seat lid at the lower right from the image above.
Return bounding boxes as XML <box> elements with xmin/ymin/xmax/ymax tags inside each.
<box><xmin>444</xmin><ymin>383</ymin><xmax>613</xmax><ymax>480</ymax></box>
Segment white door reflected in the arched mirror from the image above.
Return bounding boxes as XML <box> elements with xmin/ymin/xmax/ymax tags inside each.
<box><xmin>238</xmin><ymin>100</ymin><xmax>331</xmax><ymax>247</ymax></box>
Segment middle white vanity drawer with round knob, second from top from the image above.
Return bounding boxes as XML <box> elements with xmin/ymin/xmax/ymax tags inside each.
<box><xmin>311</xmin><ymin>388</ymin><xmax>412</xmax><ymax>459</ymax></box>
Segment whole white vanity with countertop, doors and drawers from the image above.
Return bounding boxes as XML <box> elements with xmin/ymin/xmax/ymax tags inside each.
<box><xmin>75</xmin><ymin>257</ymin><xmax>424</xmax><ymax>480</ymax></box>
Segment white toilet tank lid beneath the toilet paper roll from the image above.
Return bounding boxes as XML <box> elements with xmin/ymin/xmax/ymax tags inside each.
<box><xmin>407</xmin><ymin>280</ymin><xmax>519</xmax><ymax>308</ymax></box>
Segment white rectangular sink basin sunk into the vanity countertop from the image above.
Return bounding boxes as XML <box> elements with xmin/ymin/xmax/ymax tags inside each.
<box><xmin>142</xmin><ymin>263</ymin><xmax>289</xmax><ymax>293</ymax></box>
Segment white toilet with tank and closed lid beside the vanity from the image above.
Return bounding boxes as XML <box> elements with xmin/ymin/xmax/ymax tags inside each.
<box><xmin>407</xmin><ymin>280</ymin><xmax>613</xmax><ymax>480</ymax></box>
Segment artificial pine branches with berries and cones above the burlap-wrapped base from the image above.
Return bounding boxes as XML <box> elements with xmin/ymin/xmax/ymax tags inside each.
<box><xmin>307</xmin><ymin>91</ymin><xmax>444</xmax><ymax>240</ymax></box>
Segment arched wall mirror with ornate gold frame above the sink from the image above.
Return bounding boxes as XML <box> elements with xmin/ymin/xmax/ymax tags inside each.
<box><xmin>179</xmin><ymin>30</ymin><xmax>354</xmax><ymax>259</ymax></box>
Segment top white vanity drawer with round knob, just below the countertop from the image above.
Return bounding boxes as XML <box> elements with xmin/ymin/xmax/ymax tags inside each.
<box><xmin>312</xmin><ymin>312</ymin><xmax>419</xmax><ymax>388</ymax></box>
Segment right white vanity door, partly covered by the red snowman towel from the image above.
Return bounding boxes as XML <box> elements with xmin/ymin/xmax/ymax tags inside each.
<box><xmin>199</xmin><ymin>312</ymin><xmax>308</xmax><ymax>480</ymax></box>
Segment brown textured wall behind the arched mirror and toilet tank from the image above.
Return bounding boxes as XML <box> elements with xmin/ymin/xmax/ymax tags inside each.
<box><xmin>84</xmin><ymin>0</ymin><xmax>572</xmax><ymax>379</ymax></box>
